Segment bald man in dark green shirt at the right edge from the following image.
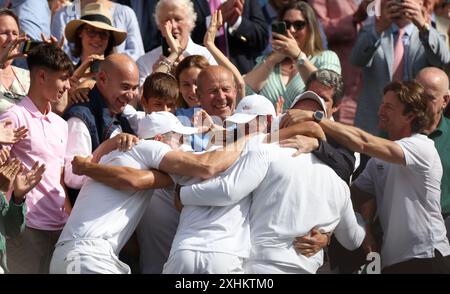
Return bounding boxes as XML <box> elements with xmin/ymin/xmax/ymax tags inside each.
<box><xmin>416</xmin><ymin>67</ymin><xmax>450</xmax><ymax>239</ymax></box>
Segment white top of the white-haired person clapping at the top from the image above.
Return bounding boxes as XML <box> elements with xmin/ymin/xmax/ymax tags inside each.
<box><xmin>136</xmin><ymin>38</ymin><xmax>217</xmax><ymax>86</ymax></box>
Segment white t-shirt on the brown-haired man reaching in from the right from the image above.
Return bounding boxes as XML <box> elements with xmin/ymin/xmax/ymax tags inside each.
<box><xmin>354</xmin><ymin>134</ymin><xmax>450</xmax><ymax>267</ymax></box>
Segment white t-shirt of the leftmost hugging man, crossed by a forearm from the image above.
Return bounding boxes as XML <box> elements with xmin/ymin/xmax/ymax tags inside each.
<box><xmin>59</xmin><ymin>140</ymin><xmax>172</xmax><ymax>254</ymax></box>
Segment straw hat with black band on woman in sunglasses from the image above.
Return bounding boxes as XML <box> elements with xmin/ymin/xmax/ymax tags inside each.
<box><xmin>64</xmin><ymin>3</ymin><xmax>127</xmax><ymax>46</ymax></box>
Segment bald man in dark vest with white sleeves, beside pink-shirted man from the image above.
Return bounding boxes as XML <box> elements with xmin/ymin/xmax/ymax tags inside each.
<box><xmin>64</xmin><ymin>54</ymin><xmax>139</xmax><ymax>205</ymax></box>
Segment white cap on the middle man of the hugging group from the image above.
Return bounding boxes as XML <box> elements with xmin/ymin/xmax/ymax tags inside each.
<box><xmin>225</xmin><ymin>94</ymin><xmax>276</xmax><ymax>124</ymax></box>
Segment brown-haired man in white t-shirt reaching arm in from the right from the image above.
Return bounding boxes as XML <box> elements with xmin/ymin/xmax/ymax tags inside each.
<box><xmin>284</xmin><ymin>81</ymin><xmax>450</xmax><ymax>273</ymax></box>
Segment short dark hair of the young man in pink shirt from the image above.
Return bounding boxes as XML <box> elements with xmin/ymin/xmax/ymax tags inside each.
<box><xmin>27</xmin><ymin>43</ymin><xmax>73</xmax><ymax>75</ymax></box>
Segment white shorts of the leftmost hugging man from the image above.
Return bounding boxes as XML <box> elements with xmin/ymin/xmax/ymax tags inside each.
<box><xmin>50</xmin><ymin>239</ymin><xmax>131</xmax><ymax>274</ymax></box>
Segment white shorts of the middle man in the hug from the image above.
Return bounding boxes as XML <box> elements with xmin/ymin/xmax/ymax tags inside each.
<box><xmin>163</xmin><ymin>250</ymin><xmax>244</xmax><ymax>274</ymax></box>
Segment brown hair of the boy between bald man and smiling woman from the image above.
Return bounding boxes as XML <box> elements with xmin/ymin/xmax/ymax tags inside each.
<box><xmin>142</xmin><ymin>72</ymin><xmax>179</xmax><ymax>101</ymax></box>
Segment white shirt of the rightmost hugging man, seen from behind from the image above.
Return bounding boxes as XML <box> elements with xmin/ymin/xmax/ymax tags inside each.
<box><xmin>181</xmin><ymin>144</ymin><xmax>365</xmax><ymax>273</ymax></box>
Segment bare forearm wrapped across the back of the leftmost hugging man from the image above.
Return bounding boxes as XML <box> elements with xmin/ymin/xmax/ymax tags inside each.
<box><xmin>83</xmin><ymin>162</ymin><xmax>173</xmax><ymax>191</ymax></box>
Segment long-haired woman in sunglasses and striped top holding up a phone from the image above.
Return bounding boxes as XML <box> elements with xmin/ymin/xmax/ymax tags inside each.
<box><xmin>244</xmin><ymin>2</ymin><xmax>341</xmax><ymax>109</ymax></box>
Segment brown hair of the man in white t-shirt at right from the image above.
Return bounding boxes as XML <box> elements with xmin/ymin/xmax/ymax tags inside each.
<box><xmin>383</xmin><ymin>81</ymin><xmax>431</xmax><ymax>133</ymax></box>
